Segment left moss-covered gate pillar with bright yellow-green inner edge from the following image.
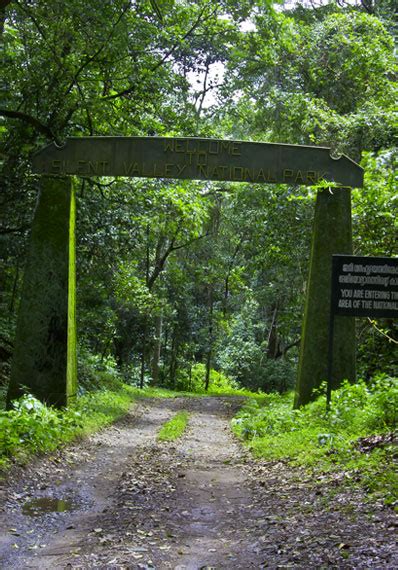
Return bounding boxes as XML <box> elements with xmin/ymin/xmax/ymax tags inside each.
<box><xmin>7</xmin><ymin>176</ymin><xmax>77</xmax><ymax>407</ymax></box>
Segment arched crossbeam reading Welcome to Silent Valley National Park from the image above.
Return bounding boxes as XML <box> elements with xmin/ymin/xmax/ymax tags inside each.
<box><xmin>32</xmin><ymin>137</ymin><xmax>363</xmax><ymax>188</ymax></box>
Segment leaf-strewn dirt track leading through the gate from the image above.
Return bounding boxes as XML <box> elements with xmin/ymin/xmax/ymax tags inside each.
<box><xmin>0</xmin><ymin>397</ymin><xmax>398</xmax><ymax>570</ymax></box>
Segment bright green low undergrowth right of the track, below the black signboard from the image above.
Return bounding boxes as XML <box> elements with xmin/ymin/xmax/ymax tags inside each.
<box><xmin>232</xmin><ymin>375</ymin><xmax>398</xmax><ymax>504</ymax></box>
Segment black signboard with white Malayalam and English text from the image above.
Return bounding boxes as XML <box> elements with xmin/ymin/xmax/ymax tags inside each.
<box><xmin>331</xmin><ymin>255</ymin><xmax>398</xmax><ymax>318</ymax></box>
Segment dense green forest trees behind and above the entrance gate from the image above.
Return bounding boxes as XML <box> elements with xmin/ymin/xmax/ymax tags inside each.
<box><xmin>0</xmin><ymin>0</ymin><xmax>397</xmax><ymax>400</ymax></box>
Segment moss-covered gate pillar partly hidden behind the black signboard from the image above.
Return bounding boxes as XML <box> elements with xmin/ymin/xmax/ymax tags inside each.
<box><xmin>295</xmin><ymin>188</ymin><xmax>355</xmax><ymax>407</ymax></box>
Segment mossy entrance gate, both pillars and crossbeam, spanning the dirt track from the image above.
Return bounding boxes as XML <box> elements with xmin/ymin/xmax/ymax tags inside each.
<box><xmin>7</xmin><ymin>137</ymin><xmax>363</xmax><ymax>406</ymax></box>
